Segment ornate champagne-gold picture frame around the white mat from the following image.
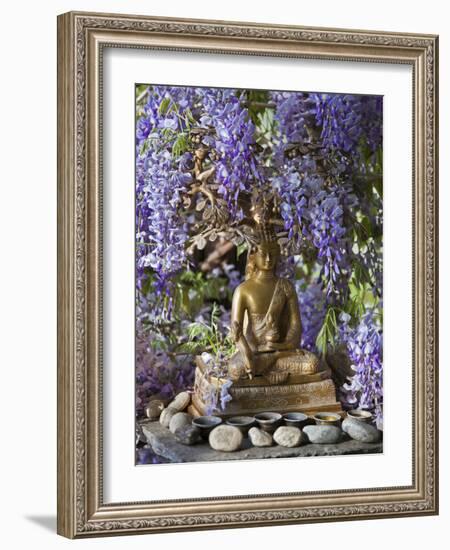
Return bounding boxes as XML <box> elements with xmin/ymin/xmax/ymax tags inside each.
<box><xmin>58</xmin><ymin>12</ymin><xmax>438</xmax><ymax>538</ymax></box>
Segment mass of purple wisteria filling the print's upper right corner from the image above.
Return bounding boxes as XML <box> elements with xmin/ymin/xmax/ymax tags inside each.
<box><xmin>271</xmin><ymin>92</ymin><xmax>382</xmax><ymax>298</ymax></box>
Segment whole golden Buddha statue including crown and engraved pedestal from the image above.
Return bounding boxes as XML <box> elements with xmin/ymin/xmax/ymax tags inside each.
<box><xmin>189</xmin><ymin>208</ymin><xmax>341</xmax><ymax>417</ymax></box>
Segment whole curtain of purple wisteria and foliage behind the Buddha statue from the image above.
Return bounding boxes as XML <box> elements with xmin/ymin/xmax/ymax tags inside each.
<box><xmin>136</xmin><ymin>85</ymin><xmax>383</xmax><ymax>423</ymax></box>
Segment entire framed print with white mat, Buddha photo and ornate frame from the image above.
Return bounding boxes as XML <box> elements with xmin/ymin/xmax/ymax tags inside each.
<box><xmin>58</xmin><ymin>12</ymin><xmax>438</xmax><ymax>538</ymax></box>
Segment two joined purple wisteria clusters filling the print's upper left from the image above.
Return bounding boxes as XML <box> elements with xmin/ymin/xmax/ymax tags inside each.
<box><xmin>136</xmin><ymin>86</ymin><xmax>260</xmax><ymax>297</ymax></box>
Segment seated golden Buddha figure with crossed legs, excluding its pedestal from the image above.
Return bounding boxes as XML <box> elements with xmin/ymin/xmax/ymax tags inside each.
<box><xmin>228</xmin><ymin>240</ymin><xmax>319</xmax><ymax>383</ymax></box>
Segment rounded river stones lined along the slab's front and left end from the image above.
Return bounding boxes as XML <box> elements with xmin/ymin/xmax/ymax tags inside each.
<box><xmin>147</xmin><ymin>392</ymin><xmax>382</xmax><ymax>452</ymax></box>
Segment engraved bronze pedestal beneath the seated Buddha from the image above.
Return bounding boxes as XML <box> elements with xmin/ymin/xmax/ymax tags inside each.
<box><xmin>189</xmin><ymin>357</ymin><xmax>342</xmax><ymax>417</ymax></box>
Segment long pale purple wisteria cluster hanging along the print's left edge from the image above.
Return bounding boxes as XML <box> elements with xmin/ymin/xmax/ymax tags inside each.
<box><xmin>136</xmin><ymin>86</ymin><xmax>194</xmax><ymax>302</ymax></box>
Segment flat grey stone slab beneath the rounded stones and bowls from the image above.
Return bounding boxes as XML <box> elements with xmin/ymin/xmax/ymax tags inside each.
<box><xmin>141</xmin><ymin>422</ymin><xmax>383</xmax><ymax>462</ymax></box>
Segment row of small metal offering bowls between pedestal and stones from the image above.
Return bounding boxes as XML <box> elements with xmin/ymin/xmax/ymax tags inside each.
<box><xmin>192</xmin><ymin>410</ymin><xmax>372</xmax><ymax>439</ymax></box>
